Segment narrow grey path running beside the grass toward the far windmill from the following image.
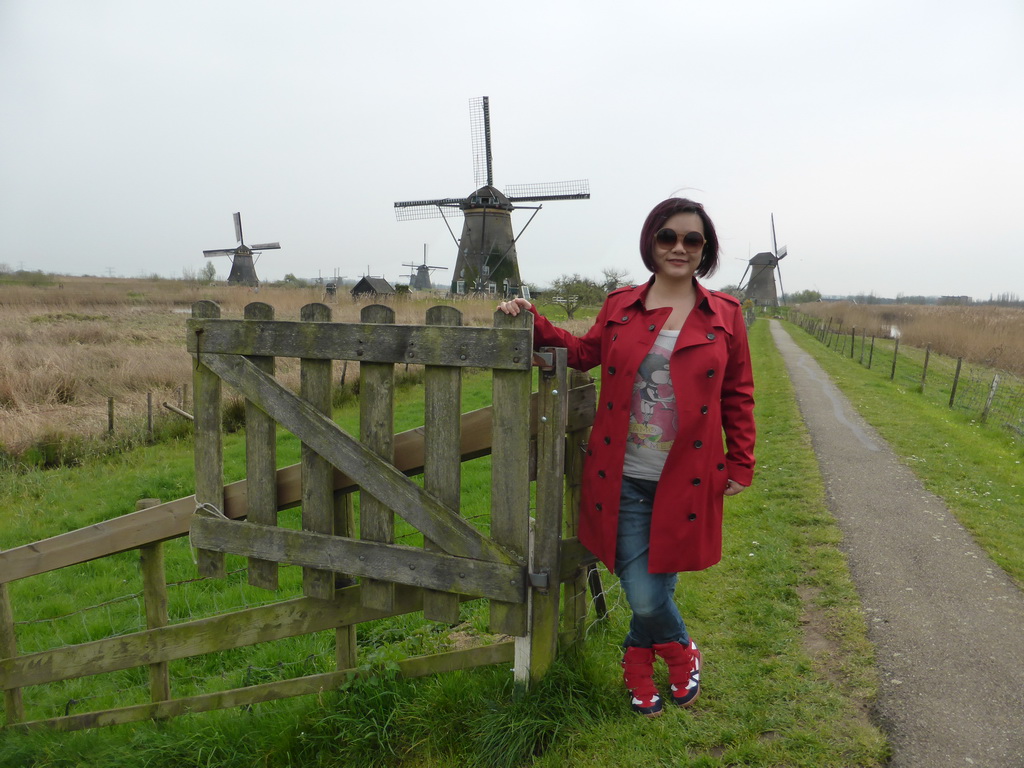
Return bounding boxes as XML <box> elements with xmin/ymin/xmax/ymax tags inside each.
<box><xmin>771</xmin><ymin>322</ymin><xmax>1024</xmax><ymax>768</ymax></box>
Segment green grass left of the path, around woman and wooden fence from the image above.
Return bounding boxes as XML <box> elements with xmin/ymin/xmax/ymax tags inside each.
<box><xmin>0</xmin><ymin>323</ymin><xmax>887</xmax><ymax>768</ymax></box>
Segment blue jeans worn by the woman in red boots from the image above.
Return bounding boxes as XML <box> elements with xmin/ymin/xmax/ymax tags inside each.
<box><xmin>615</xmin><ymin>477</ymin><xmax>690</xmax><ymax>648</ymax></box>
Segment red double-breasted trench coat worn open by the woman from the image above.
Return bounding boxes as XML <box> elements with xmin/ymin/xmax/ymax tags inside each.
<box><xmin>532</xmin><ymin>281</ymin><xmax>755</xmax><ymax>573</ymax></box>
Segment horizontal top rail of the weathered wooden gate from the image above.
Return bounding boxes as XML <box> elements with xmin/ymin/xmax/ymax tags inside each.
<box><xmin>187</xmin><ymin>319</ymin><xmax>532</xmax><ymax>371</ymax></box>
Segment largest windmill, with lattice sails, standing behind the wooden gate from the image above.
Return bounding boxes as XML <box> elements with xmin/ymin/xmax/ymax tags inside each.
<box><xmin>394</xmin><ymin>96</ymin><xmax>590</xmax><ymax>296</ymax></box>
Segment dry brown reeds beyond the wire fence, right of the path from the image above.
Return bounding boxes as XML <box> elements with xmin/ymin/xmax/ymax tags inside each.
<box><xmin>797</xmin><ymin>301</ymin><xmax>1024</xmax><ymax>376</ymax></box>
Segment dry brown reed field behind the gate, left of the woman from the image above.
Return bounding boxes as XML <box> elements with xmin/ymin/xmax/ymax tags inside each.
<box><xmin>0</xmin><ymin>278</ymin><xmax>503</xmax><ymax>455</ymax></box>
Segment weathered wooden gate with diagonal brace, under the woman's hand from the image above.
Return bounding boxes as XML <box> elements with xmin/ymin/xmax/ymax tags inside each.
<box><xmin>188</xmin><ymin>302</ymin><xmax>593</xmax><ymax>684</ymax></box>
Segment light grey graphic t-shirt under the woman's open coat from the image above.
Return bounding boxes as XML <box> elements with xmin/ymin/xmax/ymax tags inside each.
<box><xmin>623</xmin><ymin>331</ymin><xmax>679</xmax><ymax>480</ymax></box>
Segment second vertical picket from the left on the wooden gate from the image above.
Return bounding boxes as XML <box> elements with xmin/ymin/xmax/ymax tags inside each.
<box><xmin>245</xmin><ymin>301</ymin><xmax>278</xmax><ymax>590</ymax></box>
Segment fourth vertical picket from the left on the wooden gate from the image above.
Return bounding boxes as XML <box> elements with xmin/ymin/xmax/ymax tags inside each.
<box><xmin>359</xmin><ymin>304</ymin><xmax>394</xmax><ymax>610</ymax></box>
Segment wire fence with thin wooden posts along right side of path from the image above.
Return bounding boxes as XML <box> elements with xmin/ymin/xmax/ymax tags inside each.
<box><xmin>790</xmin><ymin>311</ymin><xmax>1024</xmax><ymax>439</ymax></box>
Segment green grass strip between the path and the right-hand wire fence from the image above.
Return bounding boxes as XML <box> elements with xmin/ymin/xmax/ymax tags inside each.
<box><xmin>786</xmin><ymin>325</ymin><xmax>1024</xmax><ymax>587</ymax></box>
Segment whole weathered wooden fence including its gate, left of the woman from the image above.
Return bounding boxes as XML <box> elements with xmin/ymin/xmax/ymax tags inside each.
<box><xmin>0</xmin><ymin>302</ymin><xmax>601</xmax><ymax>730</ymax></box>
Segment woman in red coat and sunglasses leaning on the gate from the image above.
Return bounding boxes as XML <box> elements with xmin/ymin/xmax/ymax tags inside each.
<box><xmin>499</xmin><ymin>198</ymin><xmax>755</xmax><ymax>717</ymax></box>
